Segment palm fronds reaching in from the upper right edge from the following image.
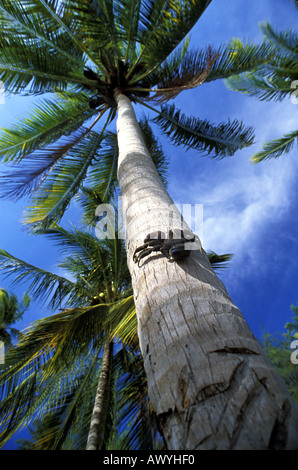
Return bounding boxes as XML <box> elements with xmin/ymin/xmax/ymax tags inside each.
<box><xmin>226</xmin><ymin>18</ymin><xmax>298</xmax><ymax>163</ymax></box>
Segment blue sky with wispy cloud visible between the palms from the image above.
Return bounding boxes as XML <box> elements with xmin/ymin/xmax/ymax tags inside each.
<box><xmin>0</xmin><ymin>0</ymin><xmax>298</xmax><ymax>450</ymax></box>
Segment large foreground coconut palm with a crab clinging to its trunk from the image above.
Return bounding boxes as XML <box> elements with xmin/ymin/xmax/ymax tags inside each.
<box><xmin>0</xmin><ymin>0</ymin><xmax>298</xmax><ymax>449</ymax></box>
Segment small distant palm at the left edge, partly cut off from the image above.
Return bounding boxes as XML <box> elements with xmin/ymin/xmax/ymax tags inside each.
<box><xmin>0</xmin><ymin>288</ymin><xmax>30</xmax><ymax>346</ymax></box>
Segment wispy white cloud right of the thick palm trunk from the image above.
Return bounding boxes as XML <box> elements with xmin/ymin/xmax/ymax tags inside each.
<box><xmin>170</xmin><ymin>136</ymin><xmax>298</xmax><ymax>284</ymax></box>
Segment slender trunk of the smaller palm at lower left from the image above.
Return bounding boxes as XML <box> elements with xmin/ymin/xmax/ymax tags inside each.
<box><xmin>86</xmin><ymin>339</ymin><xmax>113</xmax><ymax>450</ymax></box>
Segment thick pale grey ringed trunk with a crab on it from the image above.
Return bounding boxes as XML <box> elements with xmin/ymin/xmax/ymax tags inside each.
<box><xmin>115</xmin><ymin>92</ymin><xmax>298</xmax><ymax>450</ymax></box>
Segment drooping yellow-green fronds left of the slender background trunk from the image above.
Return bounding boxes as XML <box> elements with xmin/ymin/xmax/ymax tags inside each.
<box><xmin>0</xmin><ymin>320</ymin><xmax>105</xmax><ymax>448</ymax></box>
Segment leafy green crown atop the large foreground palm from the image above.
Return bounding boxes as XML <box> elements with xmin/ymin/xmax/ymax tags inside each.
<box><xmin>0</xmin><ymin>0</ymin><xmax>271</xmax><ymax>228</ymax></box>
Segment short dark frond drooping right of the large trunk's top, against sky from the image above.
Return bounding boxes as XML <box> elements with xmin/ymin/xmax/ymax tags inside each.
<box><xmin>153</xmin><ymin>105</ymin><xmax>253</xmax><ymax>157</ymax></box>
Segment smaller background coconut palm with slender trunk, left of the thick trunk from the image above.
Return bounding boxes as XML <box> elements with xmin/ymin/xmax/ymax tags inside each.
<box><xmin>0</xmin><ymin>227</ymin><xmax>156</xmax><ymax>449</ymax></box>
